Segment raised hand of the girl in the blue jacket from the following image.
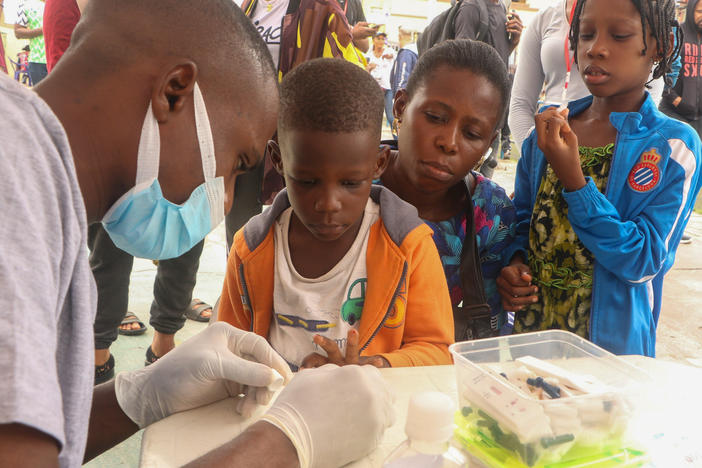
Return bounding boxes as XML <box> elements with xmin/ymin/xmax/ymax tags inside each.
<box><xmin>535</xmin><ymin>107</ymin><xmax>587</xmax><ymax>192</ymax></box>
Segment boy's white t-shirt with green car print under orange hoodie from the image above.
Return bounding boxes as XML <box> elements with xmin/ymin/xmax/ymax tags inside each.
<box><xmin>269</xmin><ymin>199</ymin><xmax>380</xmax><ymax>370</ymax></box>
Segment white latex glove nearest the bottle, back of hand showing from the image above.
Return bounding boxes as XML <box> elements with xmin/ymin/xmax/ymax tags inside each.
<box><xmin>262</xmin><ymin>364</ymin><xmax>394</xmax><ymax>468</ymax></box>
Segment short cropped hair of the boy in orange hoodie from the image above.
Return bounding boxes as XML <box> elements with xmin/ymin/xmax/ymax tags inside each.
<box><xmin>278</xmin><ymin>58</ymin><xmax>384</xmax><ymax>136</ymax></box>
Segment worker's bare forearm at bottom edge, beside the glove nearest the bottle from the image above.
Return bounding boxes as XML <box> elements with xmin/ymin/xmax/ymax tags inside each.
<box><xmin>187</xmin><ymin>421</ymin><xmax>300</xmax><ymax>468</ymax></box>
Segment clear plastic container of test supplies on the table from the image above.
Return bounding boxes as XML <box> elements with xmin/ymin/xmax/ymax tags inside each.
<box><xmin>449</xmin><ymin>330</ymin><xmax>651</xmax><ymax>468</ymax></box>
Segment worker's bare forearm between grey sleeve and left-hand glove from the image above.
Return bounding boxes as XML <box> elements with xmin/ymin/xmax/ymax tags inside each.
<box><xmin>84</xmin><ymin>380</ymin><xmax>139</xmax><ymax>462</ymax></box>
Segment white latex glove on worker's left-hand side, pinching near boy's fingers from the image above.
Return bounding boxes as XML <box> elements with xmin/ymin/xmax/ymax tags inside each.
<box><xmin>115</xmin><ymin>322</ymin><xmax>292</xmax><ymax>428</ymax></box>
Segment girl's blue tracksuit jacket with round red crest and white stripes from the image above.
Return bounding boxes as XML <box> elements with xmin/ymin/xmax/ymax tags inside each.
<box><xmin>505</xmin><ymin>96</ymin><xmax>702</xmax><ymax>356</ymax></box>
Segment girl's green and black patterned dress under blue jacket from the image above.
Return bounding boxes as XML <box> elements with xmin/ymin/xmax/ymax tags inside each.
<box><xmin>514</xmin><ymin>144</ymin><xmax>614</xmax><ymax>338</ymax></box>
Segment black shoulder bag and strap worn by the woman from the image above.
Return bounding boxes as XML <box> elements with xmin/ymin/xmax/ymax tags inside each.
<box><xmin>453</xmin><ymin>181</ymin><xmax>500</xmax><ymax>342</ymax></box>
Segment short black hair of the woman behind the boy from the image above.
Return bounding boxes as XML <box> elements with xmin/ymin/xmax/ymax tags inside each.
<box><xmin>407</xmin><ymin>39</ymin><xmax>510</xmax><ymax>128</ymax></box>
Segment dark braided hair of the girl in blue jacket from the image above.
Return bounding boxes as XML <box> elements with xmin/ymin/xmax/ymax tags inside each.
<box><xmin>568</xmin><ymin>0</ymin><xmax>683</xmax><ymax>84</ymax></box>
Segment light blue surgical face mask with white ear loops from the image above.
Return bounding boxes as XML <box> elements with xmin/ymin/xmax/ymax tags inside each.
<box><xmin>102</xmin><ymin>83</ymin><xmax>224</xmax><ymax>260</ymax></box>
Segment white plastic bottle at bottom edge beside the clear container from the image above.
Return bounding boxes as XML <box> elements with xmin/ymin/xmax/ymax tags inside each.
<box><xmin>383</xmin><ymin>392</ymin><xmax>468</xmax><ymax>468</ymax></box>
